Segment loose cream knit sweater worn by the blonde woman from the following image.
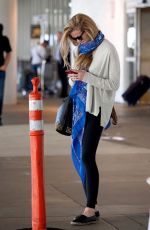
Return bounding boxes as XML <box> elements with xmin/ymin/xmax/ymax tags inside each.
<box><xmin>69</xmin><ymin>39</ymin><xmax>120</xmax><ymax>127</ymax></box>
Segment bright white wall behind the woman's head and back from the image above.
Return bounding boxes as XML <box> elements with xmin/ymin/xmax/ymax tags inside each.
<box><xmin>71</xmin><ymin>0</ymin><xmax>125</xmax><ymax>102</ymax></box>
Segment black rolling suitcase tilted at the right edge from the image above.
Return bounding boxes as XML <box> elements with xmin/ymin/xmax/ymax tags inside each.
<box><xmin>122</xmin><ymin>75</ymin><xmax>150</xmax><ymax>105</ymax></box>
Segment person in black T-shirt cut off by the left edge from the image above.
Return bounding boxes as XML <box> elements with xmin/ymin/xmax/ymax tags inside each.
<box><xmin>0</xmin><ymin>23</ymin><xmax>12</xmax><ymax>126</ymax></box>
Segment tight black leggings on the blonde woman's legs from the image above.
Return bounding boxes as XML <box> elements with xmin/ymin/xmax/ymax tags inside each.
<box><xmin>82</xmin><ymin>113</ymin><xmax>103</xmax><ymax>208</ymax></box>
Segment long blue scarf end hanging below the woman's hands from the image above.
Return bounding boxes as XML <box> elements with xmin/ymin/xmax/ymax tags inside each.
<box><xmin>70</xmin><ymin>81</ymin><xmax>87</xmax><ymax>188</ymax></box>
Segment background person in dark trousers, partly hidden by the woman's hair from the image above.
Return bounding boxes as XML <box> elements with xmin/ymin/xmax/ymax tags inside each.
<box><xmin>54</xmin><ymin>31</ymin><xmax>69</xmax><ymax>97</ymax></box>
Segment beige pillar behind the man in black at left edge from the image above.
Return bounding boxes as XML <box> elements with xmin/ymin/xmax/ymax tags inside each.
<box><xmin>0</xmin><ymin>0</ymin><xmax>17</xmax><ymax>104</ymax></box>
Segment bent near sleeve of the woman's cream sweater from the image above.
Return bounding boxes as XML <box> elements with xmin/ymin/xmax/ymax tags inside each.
<box><xmin>83</xmin><ymin>49</ymin><xmax>120</xmax><ymax>90</ymax></box>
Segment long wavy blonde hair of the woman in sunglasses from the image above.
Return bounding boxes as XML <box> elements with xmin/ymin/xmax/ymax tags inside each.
<box><xmin>60</xmin><ymin>13</ymin><xmax>99</xmax><ymax>69</ymax></box>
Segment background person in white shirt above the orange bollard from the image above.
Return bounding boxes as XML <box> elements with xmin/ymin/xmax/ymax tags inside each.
<box><xmin>31</xmin><ymin>40</ymin><xmax>48</xmax><ymax>76</ymax></box>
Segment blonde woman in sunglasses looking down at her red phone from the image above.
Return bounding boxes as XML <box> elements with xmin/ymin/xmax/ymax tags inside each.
<box><xmin>61</xmin><ymin>14</ymin><xmax>120</xmax><ymax>225</ymax></box>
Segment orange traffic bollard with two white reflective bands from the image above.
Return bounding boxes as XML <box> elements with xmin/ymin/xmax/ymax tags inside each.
<box><xmin>29</xmin><ymin>77</ymin><xmax>46</xmax><ymax>230</ymax></box>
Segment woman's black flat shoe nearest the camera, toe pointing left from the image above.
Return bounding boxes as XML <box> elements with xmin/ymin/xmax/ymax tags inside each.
<box><xmin>71</xmin><ymin>214</ymin><xmax>97</xmax><ymax>225</ymax></box>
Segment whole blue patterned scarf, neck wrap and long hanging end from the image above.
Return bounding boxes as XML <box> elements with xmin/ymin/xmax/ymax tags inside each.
<box><xmin>70</xmin><ymin>32</ymin><xmax>104</xmax><ymax>191</ymax></box>
